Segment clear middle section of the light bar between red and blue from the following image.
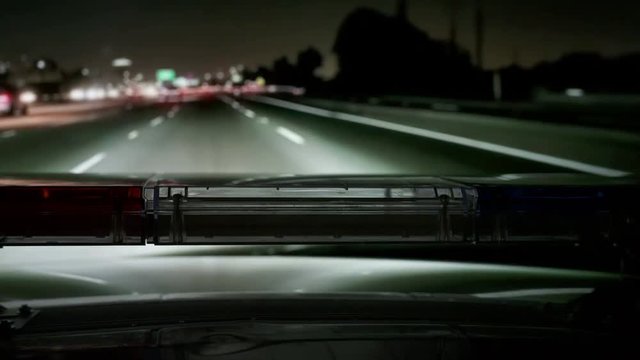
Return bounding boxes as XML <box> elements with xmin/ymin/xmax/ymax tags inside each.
<box><xmin>145</xmin><ymin>186</ymin><xmax>477</xmax><ymax>244</ymax></box>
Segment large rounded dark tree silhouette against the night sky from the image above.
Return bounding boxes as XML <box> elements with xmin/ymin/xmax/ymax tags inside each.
<box><xmin>333</xmin><ymin>8</ymin><xmax>477</xmax><ymax>96</ymax></box>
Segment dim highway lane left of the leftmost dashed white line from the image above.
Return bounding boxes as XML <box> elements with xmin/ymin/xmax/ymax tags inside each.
<box><xmin>0</xmin><ymin>107</ymin><xmax>167</xmax><ymax>174</ymax></box>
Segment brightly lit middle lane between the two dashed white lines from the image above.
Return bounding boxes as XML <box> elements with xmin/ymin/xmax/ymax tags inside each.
<box><xmin>90</xmin><ymin>101</ymin><xmax>391</xmax><ymax>175</ymax></box>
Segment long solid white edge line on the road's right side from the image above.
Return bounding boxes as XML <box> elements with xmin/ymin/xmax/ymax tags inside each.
<box><xmin>252</xmin><ymin>96</ymin><xmax>630</xmax><ymax>177</ymax></box>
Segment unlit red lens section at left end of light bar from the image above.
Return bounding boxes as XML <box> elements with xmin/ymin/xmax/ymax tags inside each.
<box><xmin>0</xmin><ymin>186</ymin><xmax>144</xmax><ymax>245</ymax></box>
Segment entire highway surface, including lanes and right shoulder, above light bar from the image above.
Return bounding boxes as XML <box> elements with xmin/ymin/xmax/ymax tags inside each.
<box><xmin>0</xmin><ymin>96</ymin><xmax>640</xmax><ymax>177</ymax></box>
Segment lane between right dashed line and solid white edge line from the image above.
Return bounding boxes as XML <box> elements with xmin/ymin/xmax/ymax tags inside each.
<box><xmin>231</xmin><ymin>101</ymin><xmax>572</xmax><ymax>176</ymax></box>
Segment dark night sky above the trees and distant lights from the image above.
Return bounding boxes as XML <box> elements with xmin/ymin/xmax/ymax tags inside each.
<box><xmin>0</xmin><ymin>0</ymin><xmax>640</xmax><ymax>75</ymax></box>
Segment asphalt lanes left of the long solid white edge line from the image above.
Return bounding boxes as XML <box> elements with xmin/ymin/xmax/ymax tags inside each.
<box><xmin>0</xmin><ymin>97</ymin><xmax>632</xmax><ymax>176</ymax></box>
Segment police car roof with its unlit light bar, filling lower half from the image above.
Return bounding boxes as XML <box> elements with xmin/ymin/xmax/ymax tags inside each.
<box><xmin>0</xmin><ymin>174</ymin><xmax>640</xmax><ymax>360</ymax></box>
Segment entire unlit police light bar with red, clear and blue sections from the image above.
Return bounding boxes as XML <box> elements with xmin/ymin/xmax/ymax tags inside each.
<box><xmin>0</xmin><ymin>177</ymin><xmax>640</xmax><ymax>255</ymax></box>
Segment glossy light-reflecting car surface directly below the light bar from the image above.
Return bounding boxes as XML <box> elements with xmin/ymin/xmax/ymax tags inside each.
<box><xmin>0</xmin><ymin>245</ymin><xmax>619</xmax><ymax>302</ymax></box>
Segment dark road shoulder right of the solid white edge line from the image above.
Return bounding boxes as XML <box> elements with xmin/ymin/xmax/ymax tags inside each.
<box><xmin>301</xmin><ymin>99</ymin><xmax>640</xmax><ymax>172</ymax></box>
